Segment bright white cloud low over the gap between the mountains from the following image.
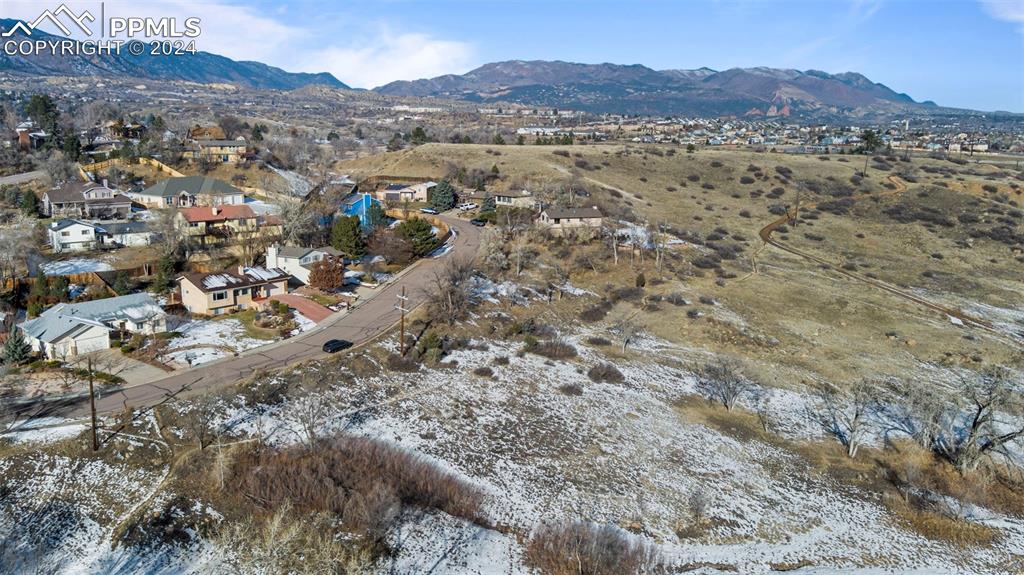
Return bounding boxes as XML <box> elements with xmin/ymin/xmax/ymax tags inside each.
<box><xmin>297</xmin><ymin>29</ymin><xmax>474</xmax><ymax>88</ymax></box>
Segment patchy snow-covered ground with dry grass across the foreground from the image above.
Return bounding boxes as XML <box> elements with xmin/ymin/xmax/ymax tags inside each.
<box><xmin>0</xmin><ymin>319</ymin><xmax>1024</xmax><ymax>575</ymax></box>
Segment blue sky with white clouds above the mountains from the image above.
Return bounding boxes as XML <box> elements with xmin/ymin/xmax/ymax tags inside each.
<box><xmin>8</xmin><ymin>0</ymin><xmax>1024</xmax><ymax>113</ymax></box>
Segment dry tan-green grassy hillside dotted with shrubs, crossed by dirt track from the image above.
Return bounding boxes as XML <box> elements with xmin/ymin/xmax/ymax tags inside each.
<box><xmin>340</xmin><ymin>144</ymin><xmax>1024</xmax><ymax>386</ymax></box>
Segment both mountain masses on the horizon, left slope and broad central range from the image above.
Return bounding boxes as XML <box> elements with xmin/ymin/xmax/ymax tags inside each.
<box><xmin>0</xmin><ymin>18</ymin><xmax>966</xmax><ymax>118</ymax></box>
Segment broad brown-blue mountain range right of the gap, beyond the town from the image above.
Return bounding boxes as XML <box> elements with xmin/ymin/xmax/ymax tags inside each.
<box><xmin>375</xmin><ymin>60</ymin><xmax>936</xmax><ymax>117</ymax></box>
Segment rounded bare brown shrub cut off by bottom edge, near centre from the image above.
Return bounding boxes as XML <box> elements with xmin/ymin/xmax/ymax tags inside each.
<box><xmin>523</xmin><ymin>522</ymin><xmax>663</xmax><ymax>575</ymax></box>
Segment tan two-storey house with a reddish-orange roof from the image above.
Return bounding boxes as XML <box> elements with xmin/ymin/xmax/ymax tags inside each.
<box><xmin>175</xmin><ymin>206</ymin><xmax>282</xmax><ymax>246</ymax></box>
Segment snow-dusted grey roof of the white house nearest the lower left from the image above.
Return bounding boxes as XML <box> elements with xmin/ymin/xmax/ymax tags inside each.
<box><xmin>20</xmin><ymin>294</ymin><xmax>165</xmax><ymax>342</ymax></box>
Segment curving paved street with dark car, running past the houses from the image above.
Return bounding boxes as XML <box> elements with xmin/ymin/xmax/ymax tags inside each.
<box><xmin>65</xmin><ymin>216</ymin><xmax>480</xmax><ymax>417</ymax></box>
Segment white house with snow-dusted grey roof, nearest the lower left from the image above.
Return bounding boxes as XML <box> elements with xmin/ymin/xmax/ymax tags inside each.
<box><xmin>18</xmin><ymin>294</ymin><xmax>167</xmax><ymax>359</ymax></box>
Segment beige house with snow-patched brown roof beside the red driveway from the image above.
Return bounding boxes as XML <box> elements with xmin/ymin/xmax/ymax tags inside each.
<box><xmin>178</xmin><ymin>266</ymin><xmax>289</xmax><ymax>315</ymax></box>
